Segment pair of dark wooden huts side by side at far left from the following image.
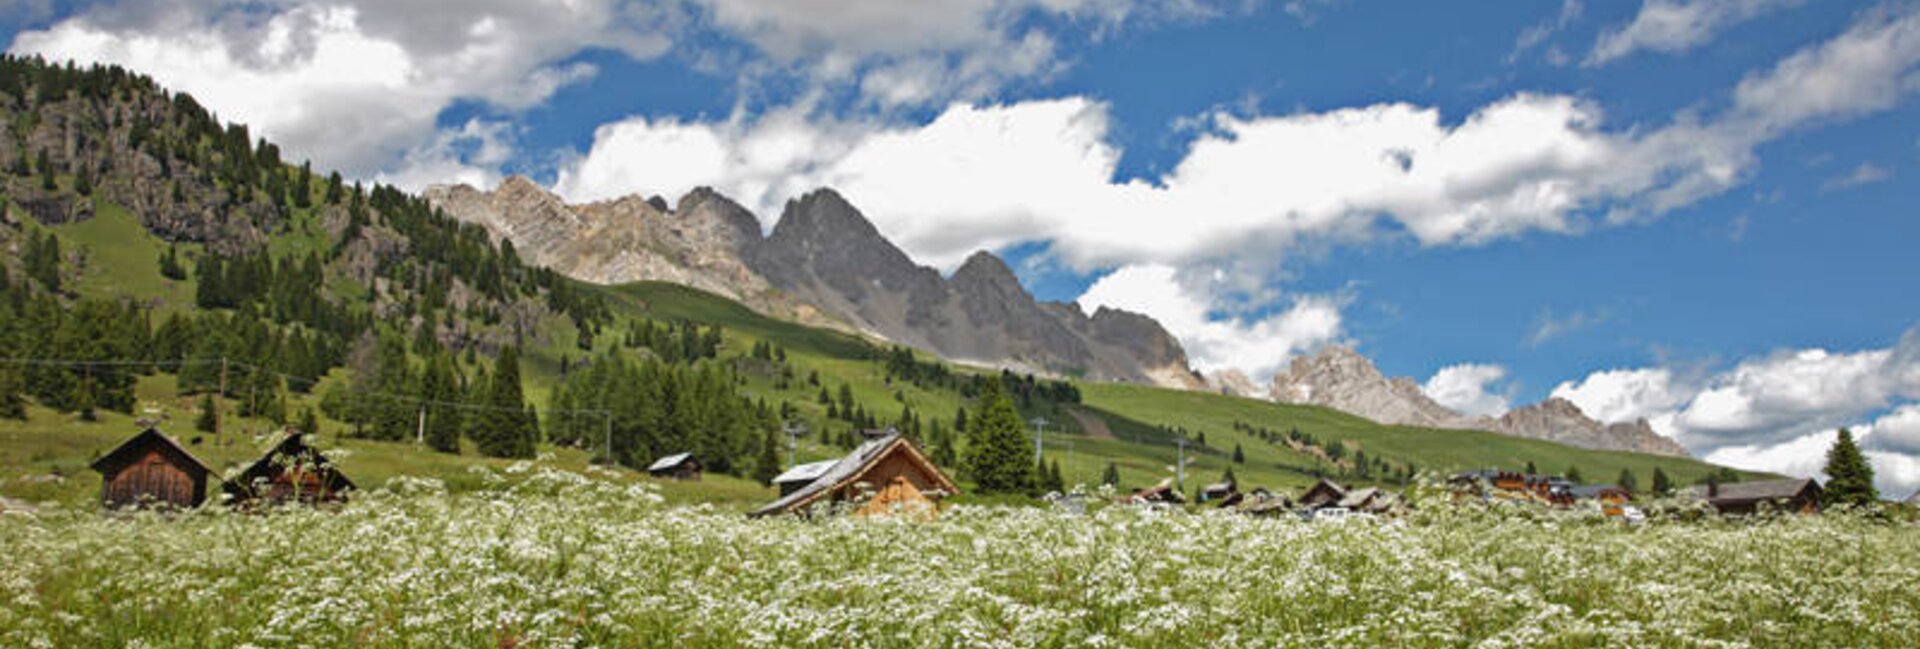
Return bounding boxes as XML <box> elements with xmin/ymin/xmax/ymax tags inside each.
<box><xmin>92</xmin><ymin>428</ymin><xmax>355</xmax><ymax>509</ymax></box>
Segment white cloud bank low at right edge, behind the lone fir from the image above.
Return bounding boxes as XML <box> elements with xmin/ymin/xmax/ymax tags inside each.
<box><xmin>1553</xmin><ymin>330</ymin><xmax>1920</xmax><ymax>493</ymax></box>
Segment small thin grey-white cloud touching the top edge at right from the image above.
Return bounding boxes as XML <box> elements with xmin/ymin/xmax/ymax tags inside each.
<box><xmin>1586</xmin><ymin>0</ymin><xmax>1801</xmax><ymax>65</ymax></box>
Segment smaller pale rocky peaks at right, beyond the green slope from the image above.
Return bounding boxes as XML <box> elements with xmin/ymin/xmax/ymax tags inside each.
<box><xmin>1269</xmin><ymin>346</ymin><xmax>1688</xmax><ymax>457</ymax></box>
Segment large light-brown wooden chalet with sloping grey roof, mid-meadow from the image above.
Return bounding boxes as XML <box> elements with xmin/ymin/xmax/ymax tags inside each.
<box><xmin>753</xmin><ymin>430</ymin><xmax>960</xmax><ymax>517</ymax></box>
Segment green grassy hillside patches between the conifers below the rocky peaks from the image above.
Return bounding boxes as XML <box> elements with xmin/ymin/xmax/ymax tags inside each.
<box><xmin>0</xmin><ymin>202</ymin><xmax>1766</xmax><ymax>507</ymax></box>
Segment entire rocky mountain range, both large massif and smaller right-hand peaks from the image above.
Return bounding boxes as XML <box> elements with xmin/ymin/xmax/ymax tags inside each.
<box><xmin>424</xmin><ymin>177</ymin><xmax>1686</xmax><ymax>455</ymax></box>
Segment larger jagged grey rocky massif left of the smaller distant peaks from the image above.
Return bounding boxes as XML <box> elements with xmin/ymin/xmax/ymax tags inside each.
<box><xmin>424</xmin><ymin>177</ymin><xmax>1200</xmax><ymax>388</ymax></box>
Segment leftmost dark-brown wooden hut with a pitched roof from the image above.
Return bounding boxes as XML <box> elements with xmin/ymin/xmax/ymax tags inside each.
<box><xmin>92</xmin><ymin>428</ymin><xmax>213</xmax><ymax>509</ymax></box>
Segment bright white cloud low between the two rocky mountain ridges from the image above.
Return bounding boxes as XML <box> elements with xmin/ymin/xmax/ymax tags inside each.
<box><xmin>1077</xmin><ymin>265</ymin><xmax>1346</xmax><ymax>382</ymax></box>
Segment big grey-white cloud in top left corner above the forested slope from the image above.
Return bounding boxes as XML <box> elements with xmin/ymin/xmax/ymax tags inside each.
<box><xmin>12</xmin><ymin>0</ymin><xmax>670</xmax><ymax>177</ymax></box>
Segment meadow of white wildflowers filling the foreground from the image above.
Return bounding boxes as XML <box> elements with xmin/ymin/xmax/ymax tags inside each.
<box><xmin>0</xmin><ymin>465</ymin><xmax>1920</xmax><ymax>647</ymax></box>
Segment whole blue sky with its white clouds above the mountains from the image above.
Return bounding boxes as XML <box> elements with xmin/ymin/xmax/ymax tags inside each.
<box><xmin>0</xmin><ymin>0</ymin><xmax>1920</xmax><ymax>490</ymax></box>
